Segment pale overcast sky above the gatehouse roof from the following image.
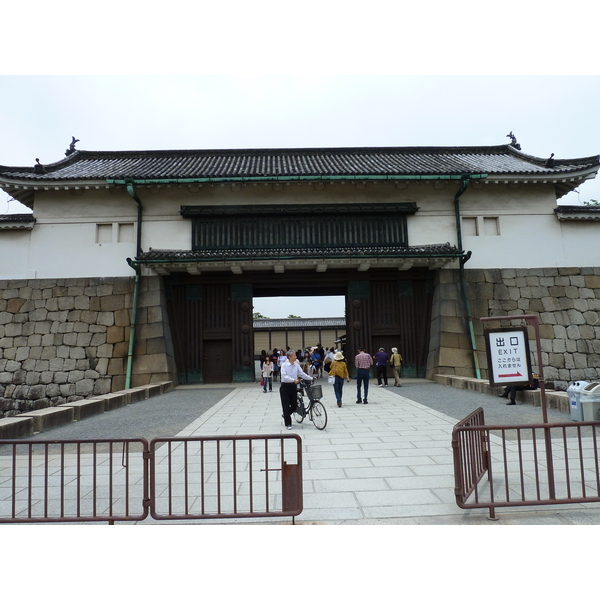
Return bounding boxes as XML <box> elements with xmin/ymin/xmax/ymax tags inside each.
<box><xmin>0</xmin><ymin>7</ymin><xmax>600</xmax><ymax>317</ymax></box>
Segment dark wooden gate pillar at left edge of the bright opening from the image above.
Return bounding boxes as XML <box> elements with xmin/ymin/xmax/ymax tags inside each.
<box><xmin>231</xmin><ymin>283</ymin><xmax>254</xmax><ymax>383</ymax></box>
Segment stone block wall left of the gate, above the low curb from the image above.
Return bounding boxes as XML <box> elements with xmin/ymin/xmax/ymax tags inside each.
<box><xmin>0</xmin><ymin>277</ymin><xmax>174</xmax><ymax>417</ymax></box>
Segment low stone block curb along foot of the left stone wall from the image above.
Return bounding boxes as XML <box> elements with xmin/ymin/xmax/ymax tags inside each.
<box><xmin>0</xmin><ymin>381</ymin><xmax>175</xmax><ymax>440</ymax></box>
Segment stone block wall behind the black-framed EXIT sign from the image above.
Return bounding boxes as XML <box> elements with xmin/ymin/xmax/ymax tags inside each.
<box><xmin>428</xmin><ymin>267</ymin><xmax>600</xmax><ymax>390</ymax></box>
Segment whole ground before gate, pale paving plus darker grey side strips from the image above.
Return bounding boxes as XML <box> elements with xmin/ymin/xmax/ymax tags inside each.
<box><xmin>4</xmin><ymin>380</ymin><xmax>600</xmax><ymax>525</ymax></box>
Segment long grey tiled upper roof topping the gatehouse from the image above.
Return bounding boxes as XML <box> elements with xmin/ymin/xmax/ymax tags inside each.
<box><xmin>0</xmin><ymin>145</ymin><xmax>600</xmax><ymax>182</ymax></box>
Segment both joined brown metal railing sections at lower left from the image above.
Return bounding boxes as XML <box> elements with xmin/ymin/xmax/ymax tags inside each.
<box><xmin>0</xmin><ymin>434</ymin><xmax>303</xmax><ymax>524</ymax></box>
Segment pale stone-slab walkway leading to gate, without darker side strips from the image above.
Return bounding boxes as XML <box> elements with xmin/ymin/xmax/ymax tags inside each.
<box><xmin>170</xmin><ymin>383</ymin><xmax>600</xmax><ymax>524</ymax></box>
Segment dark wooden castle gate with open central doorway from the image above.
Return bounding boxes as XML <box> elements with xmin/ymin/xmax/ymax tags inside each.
<box><xmin>165</xmin><ymin>269</ymin><xmax>433</xmax><ymax>384</ymax></box>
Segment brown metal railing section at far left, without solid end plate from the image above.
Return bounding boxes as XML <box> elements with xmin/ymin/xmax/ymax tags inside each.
<box><xmin>0</xmin><ymin>438</ymin><xmax>148</xmax><ymax>523</ymax></box>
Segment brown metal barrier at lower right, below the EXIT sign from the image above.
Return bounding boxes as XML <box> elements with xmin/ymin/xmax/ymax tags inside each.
<box><xmin>452</xmin><ymin>408</ymin><xmax>600</xmax><ymax>519</ymax></box>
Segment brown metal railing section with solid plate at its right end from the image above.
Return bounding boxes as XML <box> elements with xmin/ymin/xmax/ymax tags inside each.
<box><xmin>150</xmin><ymin>434</ymin><xmax>303</xmax><ymax>519</ymax></box>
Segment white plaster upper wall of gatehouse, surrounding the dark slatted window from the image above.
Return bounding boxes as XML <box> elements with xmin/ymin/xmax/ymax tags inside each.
<box><xmin>0</xmin><ymin>182</ymin><xmax>600</xmax><ymax>279</ymax></box>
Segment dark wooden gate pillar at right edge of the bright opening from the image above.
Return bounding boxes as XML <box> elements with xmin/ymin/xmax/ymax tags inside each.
<box><xmin>345</xmin><ymin>281</ymin><xmax>372</xmax><ymax>377</ymax></box>
